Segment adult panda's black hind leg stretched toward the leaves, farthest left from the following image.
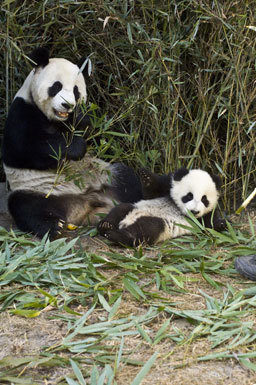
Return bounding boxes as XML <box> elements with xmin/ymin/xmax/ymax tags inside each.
<box><xmin>8</xmin><ymin>190</ymin><xmax>66</xmax><ymax>239</ymax></box>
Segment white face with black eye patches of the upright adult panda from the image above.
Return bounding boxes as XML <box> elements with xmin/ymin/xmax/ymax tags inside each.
<box><xmin>31</xmin><ymin>58</ymin><xmax>87</xmax><ymax>121</ymax></box>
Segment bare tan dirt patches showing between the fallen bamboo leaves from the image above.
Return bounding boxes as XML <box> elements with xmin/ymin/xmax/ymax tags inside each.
<box><xmin>0</xmin><ymin>184</ymin><xmax>256</xmax><ymax>385</ymax></box>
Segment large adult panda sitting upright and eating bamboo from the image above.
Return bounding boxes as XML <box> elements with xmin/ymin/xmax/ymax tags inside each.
<box><xmin>2</xmin><ymin>48</ymin><xmax>142</xmax><ymax>239</ymax></box>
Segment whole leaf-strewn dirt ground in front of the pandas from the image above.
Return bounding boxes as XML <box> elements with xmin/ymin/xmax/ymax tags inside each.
<box><xmin>0</xmin><ymin>184</ymin><xmax>256</xmax><ymax>385</ymax></box>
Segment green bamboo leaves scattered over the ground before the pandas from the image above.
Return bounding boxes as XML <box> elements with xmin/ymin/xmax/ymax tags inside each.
<box><xmin>0</xmin><ymin>218</ymin><xmax>256</xmax><ymax>385</ymax></box>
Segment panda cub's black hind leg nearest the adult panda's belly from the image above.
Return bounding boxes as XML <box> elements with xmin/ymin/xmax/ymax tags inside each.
<box><xmin>97</xmin><ymin>203</ymin><xmax>134</xmax><ymax>236</ymax></box>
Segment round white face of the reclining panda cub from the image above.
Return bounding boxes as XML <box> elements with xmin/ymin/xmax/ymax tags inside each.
<box><xmin>170</xmin><ymin>169</ymin><xmax>219</xmax><ymax>218</ymax></box>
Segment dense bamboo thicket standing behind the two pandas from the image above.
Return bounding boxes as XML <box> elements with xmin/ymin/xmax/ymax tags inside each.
<box><xmin>0</xmin><ymin>0</ymin><xmax>256</xmax><ymax>211</ymax></box>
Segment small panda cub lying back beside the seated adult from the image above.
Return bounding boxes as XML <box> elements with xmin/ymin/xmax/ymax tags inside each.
<box><xmin>98</xmin><ymin>168</ymin><xmax>225</xmax><ymax>246</ymax></box>
